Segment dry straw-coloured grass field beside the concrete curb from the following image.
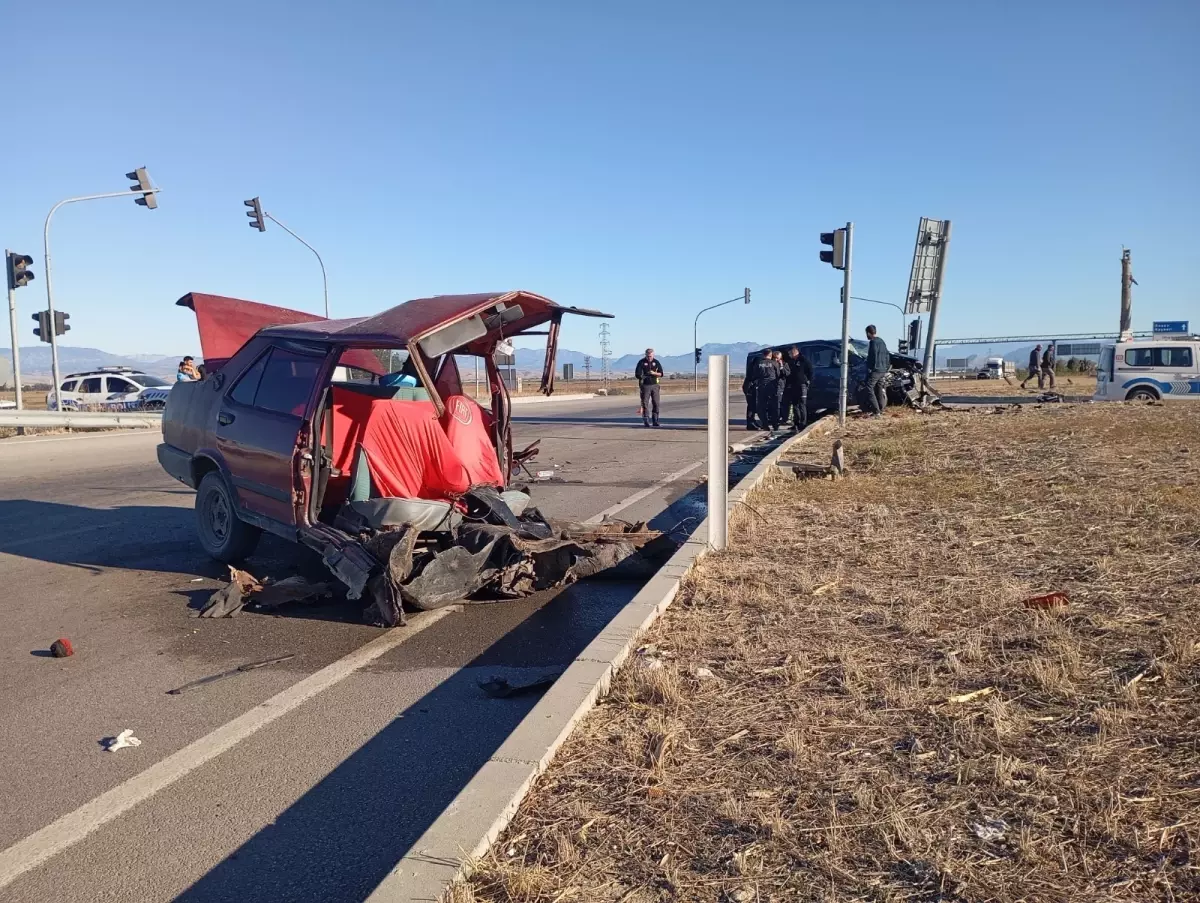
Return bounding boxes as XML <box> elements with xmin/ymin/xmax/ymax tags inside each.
<box><xmin>458</xmin><ymin>405</ymin><xmax>1200</xmax><ymax>903</ymax></box>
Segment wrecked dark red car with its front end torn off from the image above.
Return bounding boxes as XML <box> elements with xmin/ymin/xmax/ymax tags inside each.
<box><xmin>158</xmin><ymin>286</ymin><xmax>611</xmax><ymax>614</ymax></box>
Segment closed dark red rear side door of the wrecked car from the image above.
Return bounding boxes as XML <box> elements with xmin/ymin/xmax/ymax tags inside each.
<box><xmin>216</xmin><ymin>341</ymin><xmax>329</xmax><ymax>525</ymax></box>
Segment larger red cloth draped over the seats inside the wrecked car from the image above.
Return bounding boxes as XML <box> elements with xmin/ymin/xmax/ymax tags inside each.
<box><xmin>326</xmin><ymin>385</ymin><xmax>477</xmax><ymax>503</ymax></box>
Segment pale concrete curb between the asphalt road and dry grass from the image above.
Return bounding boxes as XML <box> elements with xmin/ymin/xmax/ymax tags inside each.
<box><xmin>367</xmin><ymin>417</ymin><xmax>836</xmax><ymax>903</ymax></box>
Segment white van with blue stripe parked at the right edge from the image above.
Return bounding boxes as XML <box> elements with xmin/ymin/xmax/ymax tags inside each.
<box><xmin>1093</xmin><ymin>335</ymin><xmax>1200</xmax><ymax>401</ymax></box>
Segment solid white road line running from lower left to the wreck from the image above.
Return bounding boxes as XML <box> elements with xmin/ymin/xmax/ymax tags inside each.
<box><xmin>0</xmin><ymin>605</ymin><xmax>461</xmax><ymax>889</ymax></box>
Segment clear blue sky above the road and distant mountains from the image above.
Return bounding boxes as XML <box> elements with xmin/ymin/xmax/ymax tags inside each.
<box><xmin>0</xmin><ymin>0</ymin><xmax>1200</xmax><ymax>354</ymax></box>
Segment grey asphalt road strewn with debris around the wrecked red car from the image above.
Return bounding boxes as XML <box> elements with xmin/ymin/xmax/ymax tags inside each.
<box><xmin>0</xmin><ymin>395</ymin><xmax>745</xmax><ymax>903</ymax></box>
